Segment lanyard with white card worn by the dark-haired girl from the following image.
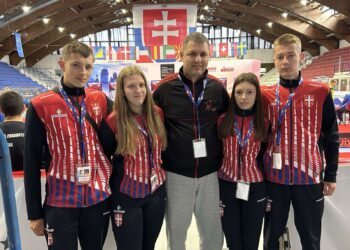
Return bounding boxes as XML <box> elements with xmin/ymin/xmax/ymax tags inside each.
<box><xmin>234</xmin><ymin>119</ymin><xmax>254</xmax><ymax>201</ymax></box>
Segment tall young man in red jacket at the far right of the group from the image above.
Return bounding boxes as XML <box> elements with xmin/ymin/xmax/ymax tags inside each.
<box><xmin>262</xmin><ymin>34</ymin><xmax>339</xmax><ymax>250</ymax></box>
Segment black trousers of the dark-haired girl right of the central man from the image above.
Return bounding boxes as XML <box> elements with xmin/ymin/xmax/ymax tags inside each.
<box><xmin>219</xmin><ymin>180</ymin><xmax>266</xmax><ymax>250</ymax></box>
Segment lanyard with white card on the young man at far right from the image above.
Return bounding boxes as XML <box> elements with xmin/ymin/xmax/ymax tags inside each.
<box><xmin>272</xmin><ymin>78</ymin><xmax>303</xmax><ymax>170</ymax></box>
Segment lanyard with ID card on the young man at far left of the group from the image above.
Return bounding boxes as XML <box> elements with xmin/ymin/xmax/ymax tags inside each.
<box><xmin>60</xmin><ymin>88</ymin><xmax>92</xmax><ymax>185</ymax></box>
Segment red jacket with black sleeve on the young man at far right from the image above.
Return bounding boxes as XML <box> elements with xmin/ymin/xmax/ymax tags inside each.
<box><xmin>261</xmin><ymin>79</ymin><xmax>339</xmax><ymax>185</ymax></box>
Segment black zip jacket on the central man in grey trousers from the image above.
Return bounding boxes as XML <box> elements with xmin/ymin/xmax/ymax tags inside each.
<box><xmin>153</xmin><ymin>68</ymin><xmax>229</xmax><ymax>177</ymax></box>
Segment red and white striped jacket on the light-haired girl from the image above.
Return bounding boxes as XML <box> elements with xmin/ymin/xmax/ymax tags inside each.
<box><xmin>100</xmin><ymin>107</ymin><xmax>166</xmax><ymax>198</ymax></box>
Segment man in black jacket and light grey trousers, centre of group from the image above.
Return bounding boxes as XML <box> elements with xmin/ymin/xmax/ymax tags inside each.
<box><xmin>153</xmin><ymin>32</ymin><xmax>229</xmax><ymax>250</ymax></box>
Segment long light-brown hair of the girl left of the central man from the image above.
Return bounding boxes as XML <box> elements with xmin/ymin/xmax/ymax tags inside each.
<box><xmin>114</xmin><ymin>66</ymin><xmax>167</xmax><ymax>155</ymax></box>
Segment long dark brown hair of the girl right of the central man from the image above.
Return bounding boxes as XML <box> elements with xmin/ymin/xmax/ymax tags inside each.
<box><xmin>219</xmin><ymin>73</ymin><xmax>266</xmax><ymax>141</ymax></box>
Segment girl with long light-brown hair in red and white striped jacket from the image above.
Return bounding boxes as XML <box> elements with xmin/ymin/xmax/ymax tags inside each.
<box><xmin>100</xmin><ymin>66</ymin><xmax>167</xmax><ymax>250</ymax></box>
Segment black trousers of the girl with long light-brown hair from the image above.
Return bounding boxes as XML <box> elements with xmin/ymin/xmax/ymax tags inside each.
<box><xmin>111</xmin><ymin>185</ymin><xmax>166</xmax><ymax>250</ymax></box>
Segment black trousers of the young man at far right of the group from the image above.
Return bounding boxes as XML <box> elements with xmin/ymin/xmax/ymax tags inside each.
<box><xmin>264</xmin><ymin>182</ymin><xmax>324</xmax><ymax>250</ymax></box>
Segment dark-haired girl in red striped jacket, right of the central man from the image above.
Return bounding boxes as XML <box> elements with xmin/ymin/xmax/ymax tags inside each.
<box><xmin>218</xmin><ymin>73</ymin><xmax>266</xmax><ymax>250</ymax></box>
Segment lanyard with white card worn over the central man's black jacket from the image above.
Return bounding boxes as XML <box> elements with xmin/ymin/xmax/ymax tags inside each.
<box><xmin>179</xmin><ymin>75</ymin><xmax>208</xmax><ymax>158</ymax></box>
